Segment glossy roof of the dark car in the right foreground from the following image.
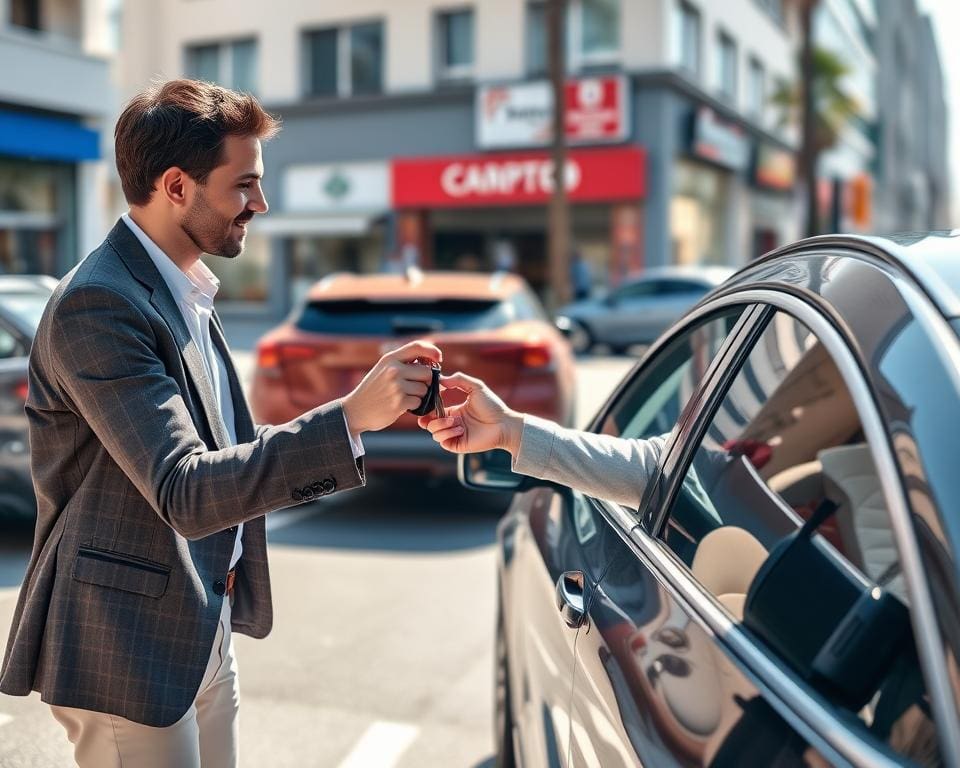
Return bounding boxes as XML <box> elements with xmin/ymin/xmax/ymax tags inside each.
<box><xmin>752</xmin><ymin>230</ymin><xmax>960</xmax><ymax>318</ymax></box>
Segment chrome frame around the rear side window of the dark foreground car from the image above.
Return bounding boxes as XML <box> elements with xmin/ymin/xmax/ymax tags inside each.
<box><xmin>634</xmin><ymin>288</ymin><xmax>960</xmax><ymax>765</ymax></box>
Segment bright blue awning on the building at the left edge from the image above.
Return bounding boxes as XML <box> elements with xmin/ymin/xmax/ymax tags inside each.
<box><xmin>0</xmin><ymin>110</ymin><xmax>100</xmax><ymax>162</ymax></box>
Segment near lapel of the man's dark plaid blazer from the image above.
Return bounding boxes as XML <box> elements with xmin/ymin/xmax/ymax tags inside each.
<box><xmin>107</xmin><ymin>219</ymin><xmax>232</xmax><ymax>448</ymax></box>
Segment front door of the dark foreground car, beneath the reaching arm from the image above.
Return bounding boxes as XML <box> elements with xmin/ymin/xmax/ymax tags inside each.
<box><xmin>499</xmin><ymin>305</ymin><xmax>749</xmax><ymax>767</ymax></box>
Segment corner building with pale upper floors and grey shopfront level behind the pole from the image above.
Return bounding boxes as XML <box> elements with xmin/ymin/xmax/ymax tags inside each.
<box><xmin>120</xmin><ymin>0</ymin><xmax>799</xmax><ymax>315</ymax></box>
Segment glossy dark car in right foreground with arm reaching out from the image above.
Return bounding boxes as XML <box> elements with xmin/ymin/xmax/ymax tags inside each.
<box><xmin>460</xmin><ymin>234</ymin><xmax>960</xmax><ymax>768</ymax></box>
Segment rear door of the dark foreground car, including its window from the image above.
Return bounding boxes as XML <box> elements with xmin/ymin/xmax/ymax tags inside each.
<box><xmin>570</xmin><ymin>296</ymin><xmax>943</xmax><ymax>768</ymax></box>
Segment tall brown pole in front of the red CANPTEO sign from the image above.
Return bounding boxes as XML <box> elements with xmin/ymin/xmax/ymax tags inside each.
<box><xmin>547</xmin><ymin>0</ymin><xmax>570</xmax><ymax>311</ymax></box>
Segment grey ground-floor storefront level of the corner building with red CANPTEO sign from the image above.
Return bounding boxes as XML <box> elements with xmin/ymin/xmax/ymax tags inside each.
<box><xmin>246</xmin><ymin>68</ymin><xmax>796</xmax><ymax>313</ymax></box>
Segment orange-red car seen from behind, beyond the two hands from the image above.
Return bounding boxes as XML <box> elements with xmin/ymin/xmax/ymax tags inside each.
<box><xmin>251</xmin><ymin>270</ymin><xmax>574</xmax><ymax>476</ymax></box>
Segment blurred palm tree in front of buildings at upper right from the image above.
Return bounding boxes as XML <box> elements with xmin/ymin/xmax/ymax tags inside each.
<box><xmin>771</xmin><ymin>47</ymin><xmax>861</xmax><ymax>236</ymax></box>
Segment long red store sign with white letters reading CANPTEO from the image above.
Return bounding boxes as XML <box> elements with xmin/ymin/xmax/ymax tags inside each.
<box><xmin>391</xmin><ymin>147</ymin><xmax>646</xmax><ymax>208</ymax></box>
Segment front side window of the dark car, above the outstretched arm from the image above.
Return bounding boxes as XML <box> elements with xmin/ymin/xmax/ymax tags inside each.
<box><xmin>601</xmin><ymin>306</ymin><xmax>744</xmax><ymax>438</ymax></box>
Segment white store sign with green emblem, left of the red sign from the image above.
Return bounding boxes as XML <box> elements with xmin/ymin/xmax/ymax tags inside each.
<box><xmin>283</xmin><ymin>162</ymin><xmax>390</xmax><ymax>213</ymax></box>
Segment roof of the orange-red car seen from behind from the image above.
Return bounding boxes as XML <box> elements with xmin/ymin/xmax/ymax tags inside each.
<box><xmin>307</xmin><ymin>269</ymin><xmax>525</xmax><ymax>301</ymax></box>
